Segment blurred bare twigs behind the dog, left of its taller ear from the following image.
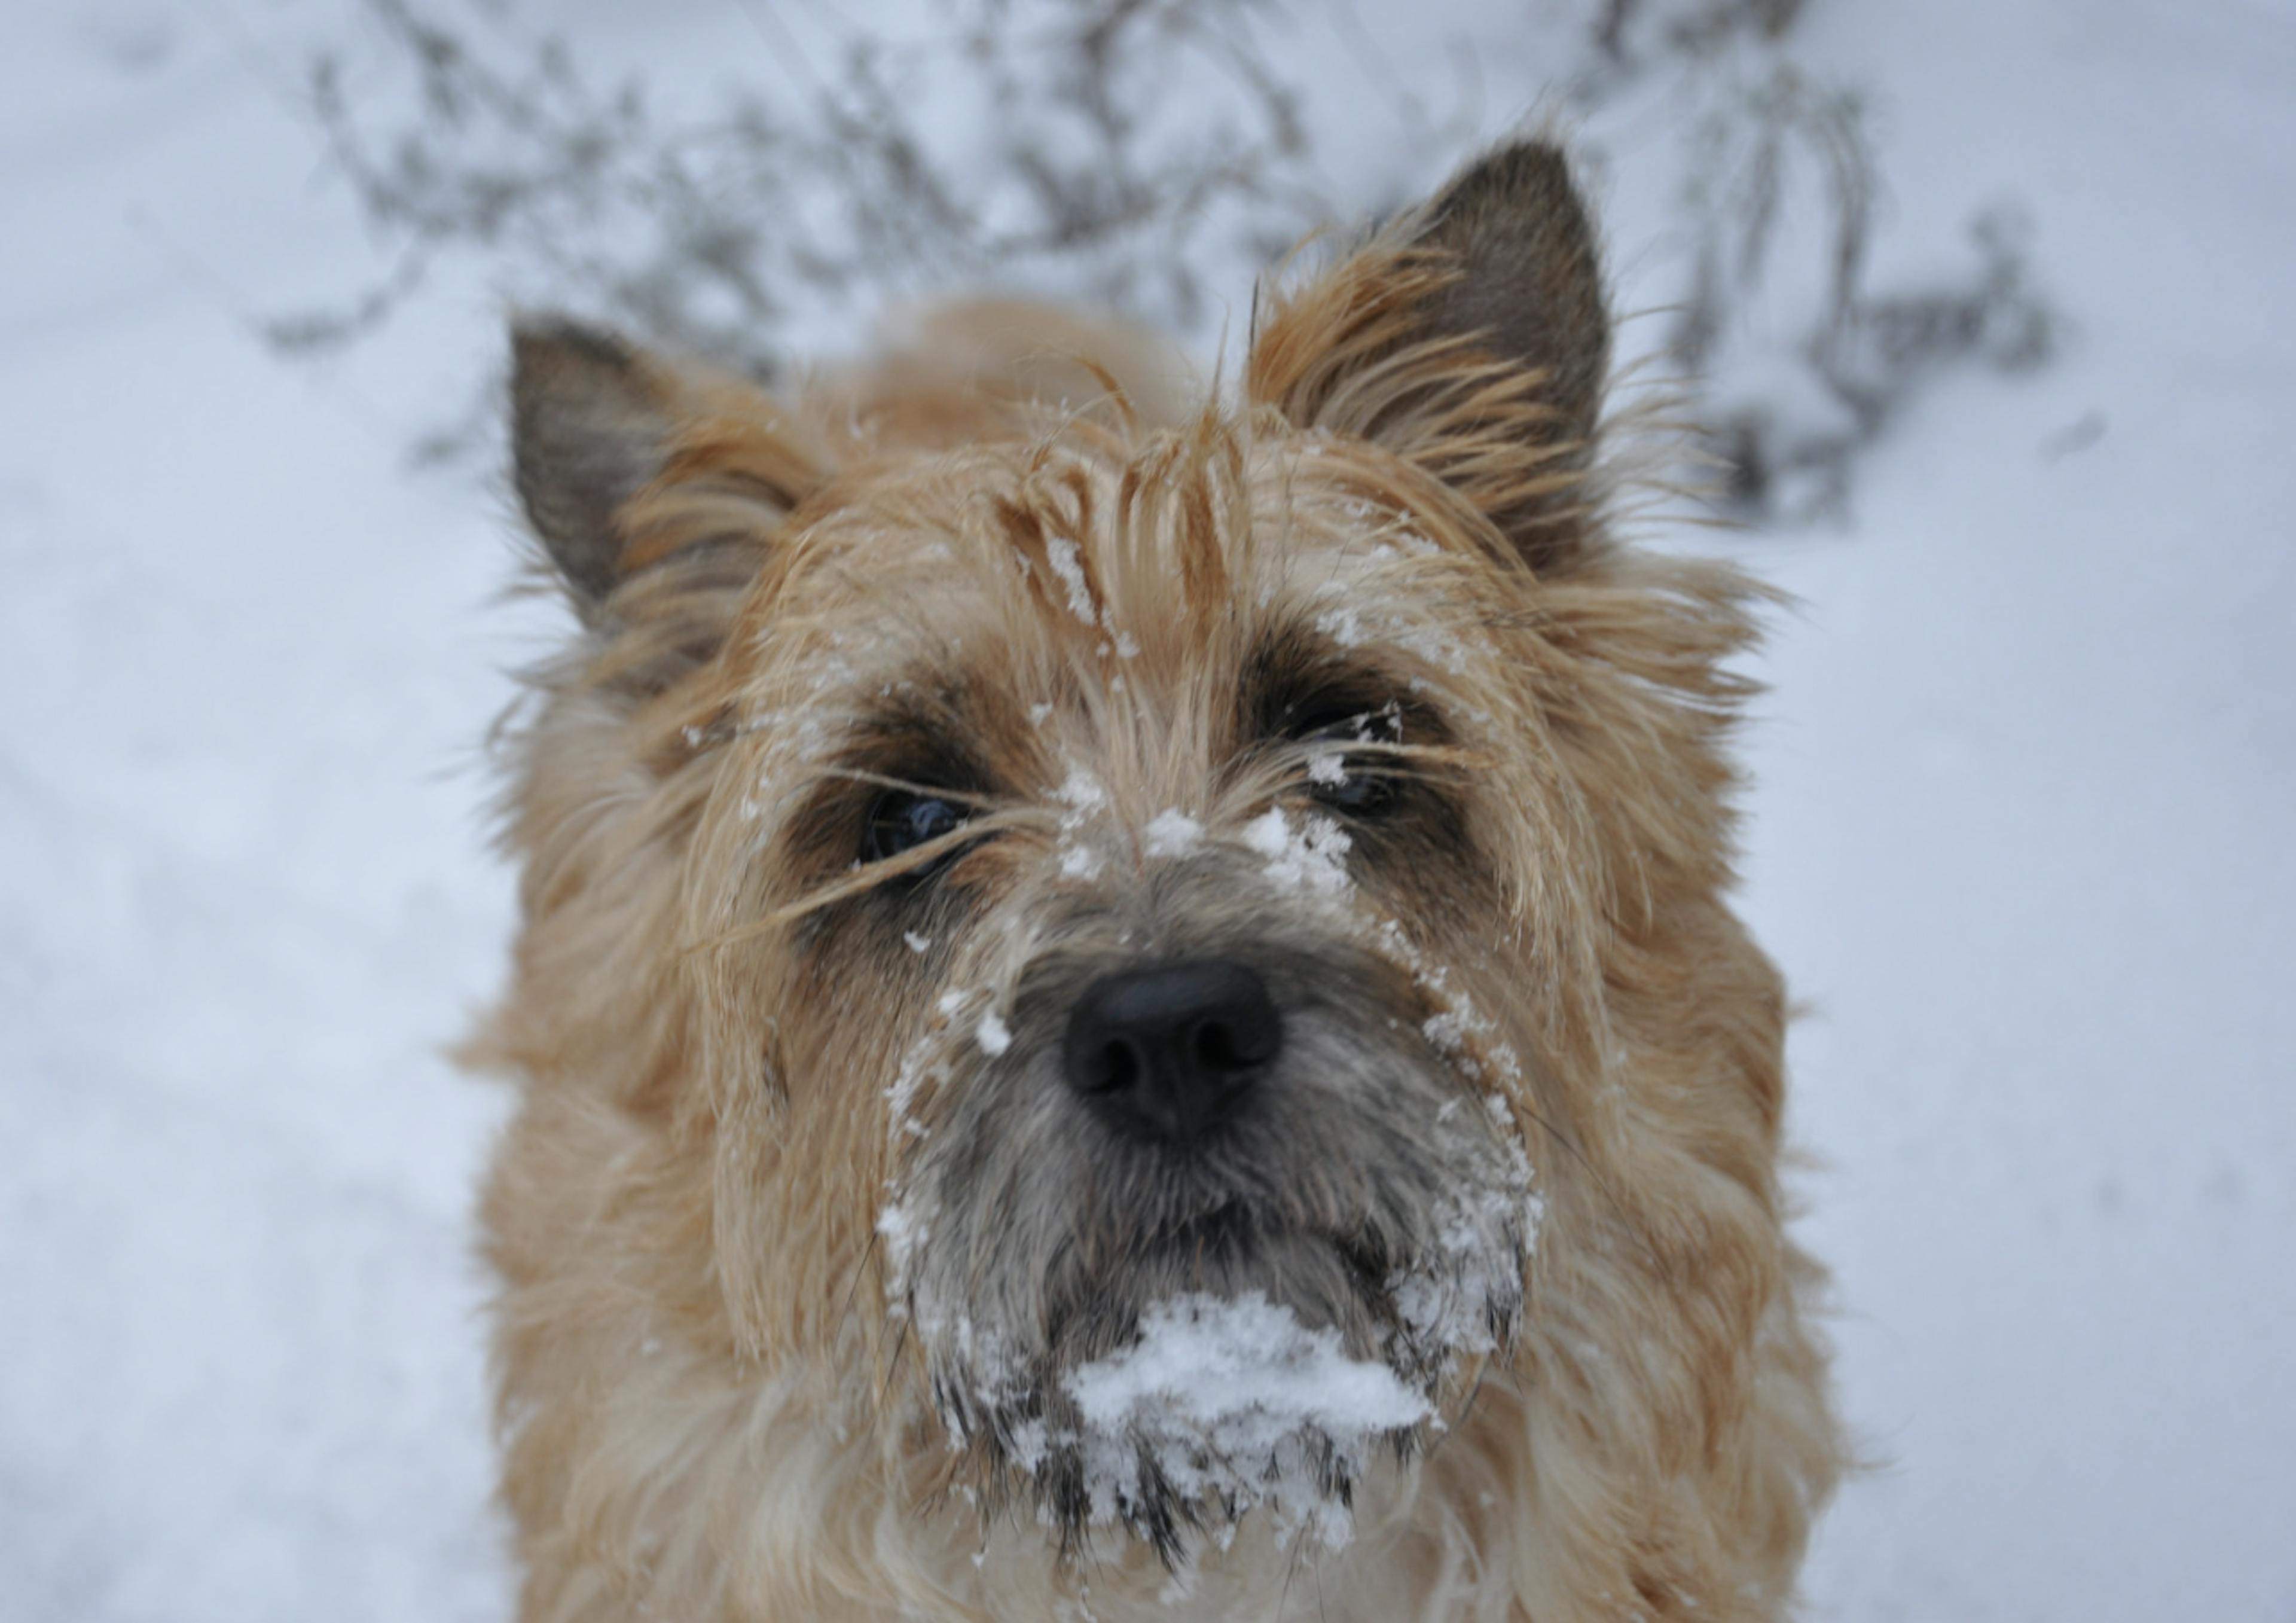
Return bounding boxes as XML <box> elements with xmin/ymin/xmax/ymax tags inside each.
<box><xmin>268</xmin><ymin>0</ymin><xmax>1336</xmax><ymax>372</ymax></box>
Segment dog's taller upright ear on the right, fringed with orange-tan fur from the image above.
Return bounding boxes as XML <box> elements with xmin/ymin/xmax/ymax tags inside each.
<box><xmin>1249</xmin><ymin>140</ymin><xmax>1610</xmax><ymax>574</ymax></box>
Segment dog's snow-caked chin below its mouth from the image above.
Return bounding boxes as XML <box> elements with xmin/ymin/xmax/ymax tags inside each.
<box><xmin>935</xmin><ymin>1205</ymin><xmax>1522</xmax><ymax>1566</ymax></box>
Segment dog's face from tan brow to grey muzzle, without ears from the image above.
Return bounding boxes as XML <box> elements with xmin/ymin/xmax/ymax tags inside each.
<box><xmin>744</xmin><ymin>422</ymin><xmax>1564</xmax><ymax>1540</ymax></box>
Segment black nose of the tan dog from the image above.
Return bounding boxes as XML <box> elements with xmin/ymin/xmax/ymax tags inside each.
<box><xmin>1061</xmin><ymin>957</ymin><xmax>1284</xmax><ymax>1143</ymax></box>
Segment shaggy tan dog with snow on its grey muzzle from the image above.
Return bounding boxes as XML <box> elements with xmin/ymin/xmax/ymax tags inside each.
<box><xmin>473</xmin><ymin>142</ymin><xmax>1844</xmax><ymax>1623</ymax></box>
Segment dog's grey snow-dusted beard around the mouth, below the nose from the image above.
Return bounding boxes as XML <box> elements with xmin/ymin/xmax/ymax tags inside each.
<box><xmin>884</xmin><ymin>992</ymin><xmax>1538</xmax><ymax>1563</ymax></box>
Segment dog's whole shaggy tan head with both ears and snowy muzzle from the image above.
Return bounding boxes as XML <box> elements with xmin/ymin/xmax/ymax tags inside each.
<box><xmin>493</xmin><ymin>147</ymin><xmax>1777</xmax><ymax>1554</ymax></box>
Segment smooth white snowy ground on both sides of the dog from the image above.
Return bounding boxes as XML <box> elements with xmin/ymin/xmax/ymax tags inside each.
<box><xmin>0</xmin><ymin>0</ymin><xmax>2296</xmax><ymax>1623</ymax></box>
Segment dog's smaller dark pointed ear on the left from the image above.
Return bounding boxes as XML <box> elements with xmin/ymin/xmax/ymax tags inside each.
<box><xmin>509</xmin><ymin>317</ymin><xmax>675</xmax><ymax>620</ymax></box>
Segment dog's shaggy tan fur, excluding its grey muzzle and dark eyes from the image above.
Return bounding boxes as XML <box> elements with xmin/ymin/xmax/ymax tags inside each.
<box><xmin>473</xmin><ymin>147</ymin><xmax>1839</xmax><ymax>1623</ymax></box>
